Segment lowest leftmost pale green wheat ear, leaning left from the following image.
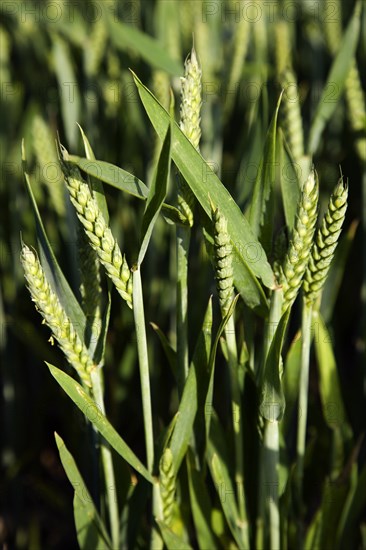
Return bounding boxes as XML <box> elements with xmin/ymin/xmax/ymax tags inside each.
<box><xmin>20</xmin><ymin>245</ymin><xmax>94</xmax><ymax>387</ymax></box>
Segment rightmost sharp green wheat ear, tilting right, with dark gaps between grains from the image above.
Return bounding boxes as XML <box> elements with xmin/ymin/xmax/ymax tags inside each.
<box><xmin>303</xmin><ymin>178</ymin><xmax>348</xmax><ymax>304</ymax></box>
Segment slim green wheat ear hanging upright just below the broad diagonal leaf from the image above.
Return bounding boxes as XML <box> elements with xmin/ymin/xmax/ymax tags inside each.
<box><xmin>211</xmin><ymin>205</ymin><xmax>234</xmax><ymax>316</ymax></box>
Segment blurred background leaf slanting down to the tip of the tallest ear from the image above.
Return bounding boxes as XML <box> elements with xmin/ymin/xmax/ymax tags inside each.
<box><xmin>103</xmin><ymin>8</ymin><xmax>183</xmax><ymax>76</ymax></box>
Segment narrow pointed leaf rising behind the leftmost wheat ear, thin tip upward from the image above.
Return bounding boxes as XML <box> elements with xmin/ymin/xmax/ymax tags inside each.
<box><xmin>22</xmin><ymin>148</ymin><xmax>86</xmax><ymax>342</ymax></box>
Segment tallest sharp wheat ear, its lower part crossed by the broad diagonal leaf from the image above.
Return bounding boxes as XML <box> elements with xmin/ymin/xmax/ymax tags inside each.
<box><xmin>178</xmin><ymin>47</ymin><xmax>202</xmax><ymax>226</ymax></box>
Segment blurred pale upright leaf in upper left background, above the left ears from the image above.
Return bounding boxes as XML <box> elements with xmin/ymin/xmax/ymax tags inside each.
<box><xmin>51</xmin><ymin>33</ymin><xmax>80</xmax><ymax>148</ymax></box>
